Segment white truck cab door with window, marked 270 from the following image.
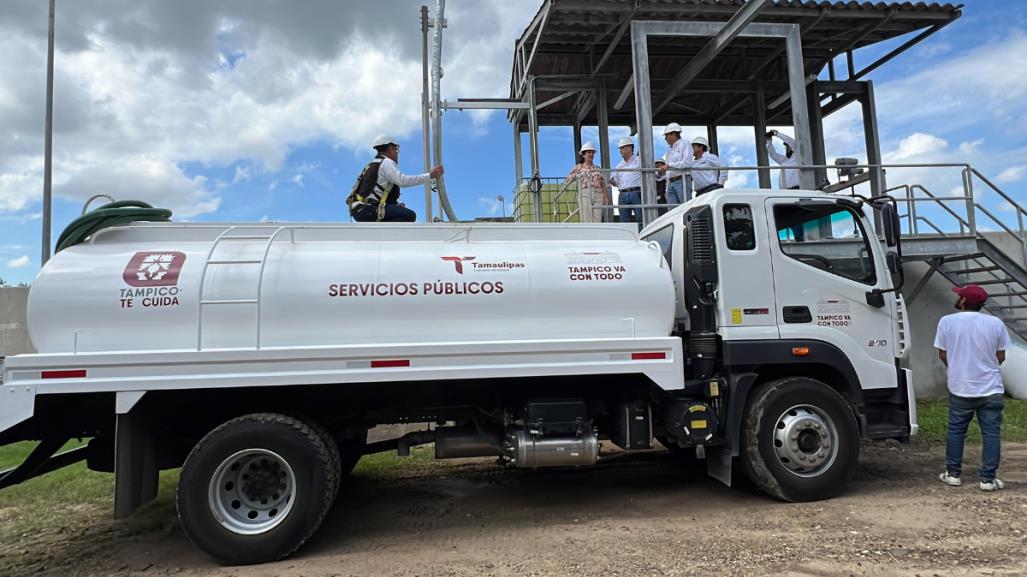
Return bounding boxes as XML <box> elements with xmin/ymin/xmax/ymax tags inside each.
<box><xmin>766</xmin><ymin>198</ymin><xmax>898</xmax><ymax>389</ymax></box>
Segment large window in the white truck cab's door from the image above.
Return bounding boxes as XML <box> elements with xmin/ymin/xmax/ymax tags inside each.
<box><xmin>773</xmin><ymin>204</ymin><xmax>877</xmax><ymax>284</ymax></box>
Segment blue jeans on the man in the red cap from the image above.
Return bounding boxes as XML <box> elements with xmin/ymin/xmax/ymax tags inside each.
<box><xmin>945</xmin><ymin>393</ymin><xmax>1003</xmax><ymax>480</ymax></box>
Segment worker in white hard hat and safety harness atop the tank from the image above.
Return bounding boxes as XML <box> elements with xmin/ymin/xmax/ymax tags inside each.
<box><xmin>346</xmin><ymin>134</ymin><xmax>444</xmax><ymax>223</ymax></box>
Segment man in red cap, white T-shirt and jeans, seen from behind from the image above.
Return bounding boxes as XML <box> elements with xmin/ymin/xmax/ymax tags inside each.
<box><xmin>935</xmin><ymin>284</ymin><xmax>1013</xmax><ymax>491</ymax></box>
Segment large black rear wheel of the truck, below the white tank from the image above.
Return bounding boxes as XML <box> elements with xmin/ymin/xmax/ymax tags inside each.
<box><xmin>177</xmin><ymin>413</ymin><xmax>338</xmax><ymax>565</ymax></box>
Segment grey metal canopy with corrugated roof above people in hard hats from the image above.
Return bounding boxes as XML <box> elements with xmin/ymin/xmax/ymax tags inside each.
<box><xmin>505</xmin><ymin>0</ymin><xmax>962</xmax><ymax>217</ymax></box>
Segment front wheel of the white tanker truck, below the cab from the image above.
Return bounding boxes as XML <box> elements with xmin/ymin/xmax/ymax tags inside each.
<box><xmin>741</xmin><ymin>377</ymin><xmax>860</xmax><ymax>501</ymax></box>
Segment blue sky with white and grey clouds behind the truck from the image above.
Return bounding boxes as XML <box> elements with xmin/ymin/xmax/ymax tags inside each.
<box><xmin>0</xmin><ymin>0</ymin><xmax>1027</xmax><ymax>282</ymax></box>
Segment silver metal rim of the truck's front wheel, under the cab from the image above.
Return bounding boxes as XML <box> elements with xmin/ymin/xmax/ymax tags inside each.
<box><xmin>773</xmin><ymin>405</ymin><xmax>838</xmax><ymax>477</ymax></box>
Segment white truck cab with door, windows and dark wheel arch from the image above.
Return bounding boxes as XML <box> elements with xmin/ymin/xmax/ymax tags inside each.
<box><xmin>641</xmin><ymin>190</ymin><xmax>916</xmax><ymax>484</ymax></box>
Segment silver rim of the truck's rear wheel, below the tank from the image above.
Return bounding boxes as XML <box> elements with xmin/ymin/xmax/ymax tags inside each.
<box><xmin>208</xmin><ymin>449</ymin><xmax>296</xmax><ymax>535</ymax></box>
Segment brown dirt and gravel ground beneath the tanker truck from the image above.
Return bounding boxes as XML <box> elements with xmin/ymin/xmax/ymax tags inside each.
<box><xmin>10</xmin><ymin>444</ymin><xmax>1027</xmax><ymax>577</ymax></box>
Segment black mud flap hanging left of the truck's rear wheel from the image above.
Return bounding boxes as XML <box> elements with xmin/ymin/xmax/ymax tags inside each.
<box><xmin>114</xmin><ymin>409</ymin><xmax>158</xmax><ymax>518</ymax></box>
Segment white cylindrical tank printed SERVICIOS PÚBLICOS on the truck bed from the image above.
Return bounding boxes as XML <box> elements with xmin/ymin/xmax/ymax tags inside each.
<box><xmin>28</xmin><ymin>223</ymin><xmax>675</xmax><ymax>353</ymax></box>
